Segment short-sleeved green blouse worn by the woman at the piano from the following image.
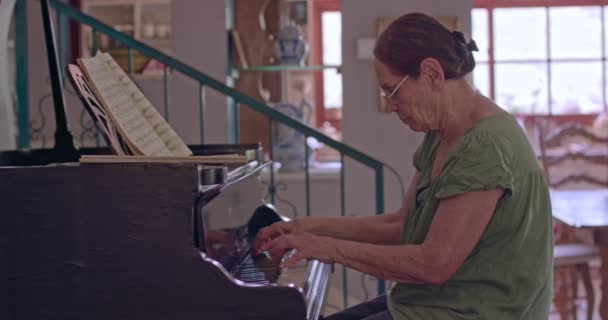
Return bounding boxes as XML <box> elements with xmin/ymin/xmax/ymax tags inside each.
<box><xmin>388</xmin><ymin>113</ymin><xmax>553</xmax><ymax>320</ymax></box>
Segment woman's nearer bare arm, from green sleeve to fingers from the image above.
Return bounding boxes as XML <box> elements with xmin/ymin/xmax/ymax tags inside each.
<box><xmin>265</xmin><ymin>189</ymin><xmax>503</xmax><ymax>284</ymax></box>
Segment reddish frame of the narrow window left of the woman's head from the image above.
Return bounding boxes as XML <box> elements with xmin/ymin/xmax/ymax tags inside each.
<box><xmin>310</xmin><ymin>0</ymin><xmax>342</xmax><ymax>131</ymax></box>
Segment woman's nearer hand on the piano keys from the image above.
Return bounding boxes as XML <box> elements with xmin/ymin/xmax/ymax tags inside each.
<box><xmin>262</xmin><ymin>232</ymin><xmax>337</xmax><ymax>268</ymax></box>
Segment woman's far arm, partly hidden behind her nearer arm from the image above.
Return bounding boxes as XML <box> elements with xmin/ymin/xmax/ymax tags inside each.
<box><xmin>254</xmin><ymin>172</ymin><xmax>419</xmax><ymax>246</ymax></box>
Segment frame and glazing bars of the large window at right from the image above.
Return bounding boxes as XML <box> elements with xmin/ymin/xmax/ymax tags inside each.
<box><xmin>473</xmin><ymin>0</ymin><xmax>608</xmax><ymax>117</ymax></box>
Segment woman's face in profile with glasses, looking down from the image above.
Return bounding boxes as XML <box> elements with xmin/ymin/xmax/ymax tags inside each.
<box><xmin>374</xmin><ymin>59</ymin><xmax>445</xmax><ymax>131</ymax></box>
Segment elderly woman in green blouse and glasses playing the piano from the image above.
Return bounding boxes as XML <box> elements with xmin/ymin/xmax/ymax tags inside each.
<box><xmin>256</xmin><ymin>14</ymin><xmax>553</xmax><ymax>320</ymax></box>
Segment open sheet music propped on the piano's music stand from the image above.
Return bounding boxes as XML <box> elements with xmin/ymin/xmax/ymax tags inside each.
<box><xmin>80</xmin><ymin>53</ymin><xmax>192</xmax><ymax>156</ymax></box>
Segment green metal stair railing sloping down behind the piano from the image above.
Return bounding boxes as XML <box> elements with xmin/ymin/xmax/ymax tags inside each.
<box><xmin>44</xmin><ymin>0</ymin><xmax>385</xmax><ymax>304</ymax></box>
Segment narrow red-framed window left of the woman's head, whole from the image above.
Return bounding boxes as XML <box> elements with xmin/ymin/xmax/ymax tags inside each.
<box><xmin>311</xmin><ymin>0</ymin><xmax>342</xmax><ymax>130</ymax></box>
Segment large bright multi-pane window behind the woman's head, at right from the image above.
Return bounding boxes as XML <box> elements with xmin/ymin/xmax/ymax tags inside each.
<box><xmin>471</xmin><ymin>0</ymin><xmax>608</xmax><ymax>115</ymax></box>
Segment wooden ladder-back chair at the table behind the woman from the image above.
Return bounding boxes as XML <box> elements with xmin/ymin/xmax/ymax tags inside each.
<box><xmin>535</xmin><ymin>119</ymin><xmax>608</xmax><ymax>320</ymax></box>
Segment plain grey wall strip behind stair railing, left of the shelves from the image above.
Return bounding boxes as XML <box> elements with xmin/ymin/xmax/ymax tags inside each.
<box><xmin>171</xmin><ymin>0</ymin><xmax>228</xmax><ymax>143</ymax></box>
